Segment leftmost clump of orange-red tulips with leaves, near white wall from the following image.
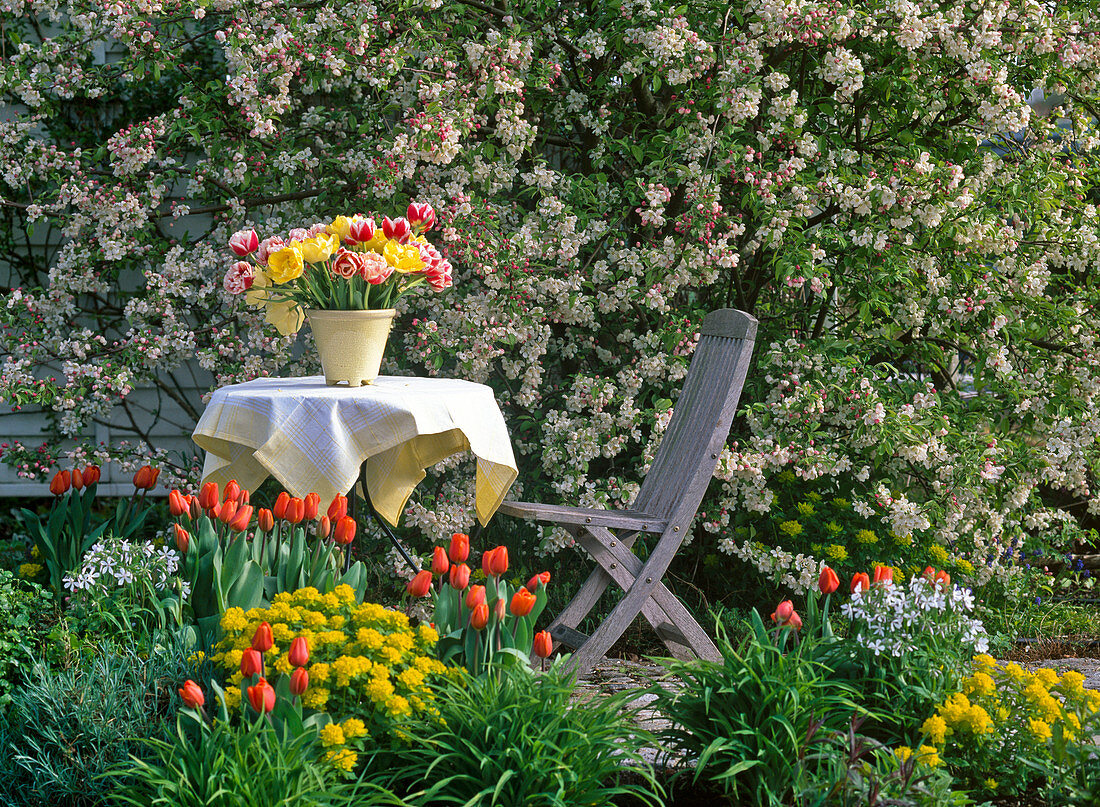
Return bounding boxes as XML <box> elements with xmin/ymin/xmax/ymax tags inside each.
<box><xmin>17</xmin><ymin>465</ymin><xmax>160</xmax><ymax>595</ymax></box>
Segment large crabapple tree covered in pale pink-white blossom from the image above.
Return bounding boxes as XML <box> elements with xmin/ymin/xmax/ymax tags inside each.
<box><xmin>0</xmin><ymin>0</ymin><xmax>1100</xmax><ymax>602</ymax></box>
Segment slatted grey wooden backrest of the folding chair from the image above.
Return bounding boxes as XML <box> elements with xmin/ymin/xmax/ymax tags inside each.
<box><xmin>630</xmin><ymin>308</ymin><xmax>757</xmax><ymax>528</ymax></box>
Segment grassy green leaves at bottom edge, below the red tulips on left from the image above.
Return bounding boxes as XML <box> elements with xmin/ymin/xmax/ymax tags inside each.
<box><xmin>114</xmin><ymin>715</ymin><xmax>402</xmax><ymax>807</ymax></box>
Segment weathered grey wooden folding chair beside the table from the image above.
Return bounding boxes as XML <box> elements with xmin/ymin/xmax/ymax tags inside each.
<box><xmin>499</xmin><ymin>308</ymin><xmax>757</xmax><ymax>674</ymax></box>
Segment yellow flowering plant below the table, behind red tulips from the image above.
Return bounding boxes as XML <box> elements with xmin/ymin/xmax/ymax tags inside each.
<box><xmin>212</xmin><ymin>585</ymin><xmax>449</xmax><ymax>771</ymax></box>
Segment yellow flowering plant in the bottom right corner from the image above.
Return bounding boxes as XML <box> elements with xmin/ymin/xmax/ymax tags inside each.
<box><xmin>921</xmin><ymin>654</ymin><xmax>1100</xmax><ymax>797</ymax></box>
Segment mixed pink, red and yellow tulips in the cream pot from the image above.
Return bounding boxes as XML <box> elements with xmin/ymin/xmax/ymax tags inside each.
<box><xmin>223</xmin><ymin>202</ymin><xmax>451</xmax><ymax>334</ymax></box>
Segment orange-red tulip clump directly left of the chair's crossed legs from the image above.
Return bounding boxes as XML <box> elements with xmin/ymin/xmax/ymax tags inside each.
<box><xmin>408</xmin><ymin>532</ymin><xmax>553</xmax><ymax>675</ymax></box>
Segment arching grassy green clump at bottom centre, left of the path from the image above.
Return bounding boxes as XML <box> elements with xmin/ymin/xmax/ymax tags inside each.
<box><xmin>369</xmin><ymin>666</ymin><xmax>663</xmax><ymax>807</ymax></box>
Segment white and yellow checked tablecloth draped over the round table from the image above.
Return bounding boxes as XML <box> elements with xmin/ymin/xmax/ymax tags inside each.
<box><xmin>193</xmin><ymin>376</ymin><xmax>518</xmax><ymax>524</ymax></box>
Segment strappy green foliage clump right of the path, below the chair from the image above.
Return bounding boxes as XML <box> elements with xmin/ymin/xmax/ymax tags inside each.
<box><xmin>652</xmin><ymin>611</ymin><xmax>860</xmax><ymax>805</ymax></box>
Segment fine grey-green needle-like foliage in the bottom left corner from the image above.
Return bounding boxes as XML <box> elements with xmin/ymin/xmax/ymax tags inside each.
<box><xmin>0</xmin><ymin>641</ymin><xmax>204</xmax><ymax>807</ymax></box>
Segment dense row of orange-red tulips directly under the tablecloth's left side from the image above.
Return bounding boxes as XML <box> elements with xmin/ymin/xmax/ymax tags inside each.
<box><xmin>168</xmin><ymin>480</ymin><xmax>366</xmax><ymax>646</ymax></box>
